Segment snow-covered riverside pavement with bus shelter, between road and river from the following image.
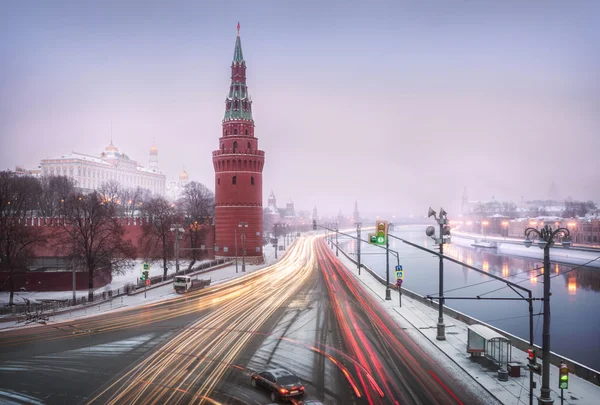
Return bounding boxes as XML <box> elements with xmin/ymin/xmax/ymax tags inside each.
<box><xmin>340</xmin><ymin>251</ymin><xmax>600</xmax><ymax>405</ymax></box>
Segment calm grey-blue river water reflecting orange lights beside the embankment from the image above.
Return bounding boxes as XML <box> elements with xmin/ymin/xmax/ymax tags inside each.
<box><xmin>340</xmin><ymin>226</ymin><xmax>600</xmax><ymax>370</ymax></box>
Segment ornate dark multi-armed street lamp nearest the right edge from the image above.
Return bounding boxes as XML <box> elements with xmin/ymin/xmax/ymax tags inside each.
<box><xmin>523</xmin><ymin>225</ymin><xmax>572</xmax><ymax>404</ymax></box>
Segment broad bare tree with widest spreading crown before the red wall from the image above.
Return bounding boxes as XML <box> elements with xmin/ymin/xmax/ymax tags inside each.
<box><xmin>58</xmin><ymin>191</ymin><xmax>136</xmax><ymax>301</ymax></box>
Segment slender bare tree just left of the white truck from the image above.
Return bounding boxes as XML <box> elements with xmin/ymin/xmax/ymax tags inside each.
<box><xmin>140</xmin><ymin>197</ymin><xmax>176</xmax><ymax>277</ymax></box>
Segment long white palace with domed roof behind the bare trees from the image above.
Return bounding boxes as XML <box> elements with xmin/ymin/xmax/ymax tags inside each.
<box><xmin>41</xmin><ymin>140</ymin><xmax>166</xmax><ymax>195</ymax></box>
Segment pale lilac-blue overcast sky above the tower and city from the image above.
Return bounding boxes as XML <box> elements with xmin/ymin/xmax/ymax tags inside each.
<box><xmin>0</xmin><ymin>0</ymin><xmax>600</xmax><ymax>215</ymax></box>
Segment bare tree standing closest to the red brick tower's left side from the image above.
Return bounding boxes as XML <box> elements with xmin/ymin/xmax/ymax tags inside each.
<box><xmin>178</xmin><ymin>181</ymin><xmax>215</xmax><ymax>268</ymax></box>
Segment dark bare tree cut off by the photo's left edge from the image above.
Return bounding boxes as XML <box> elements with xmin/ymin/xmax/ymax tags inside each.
<box><xmin>0</xmin><ymin>172</ymin><xmax>44</xmax><ymax>305</ymax></box>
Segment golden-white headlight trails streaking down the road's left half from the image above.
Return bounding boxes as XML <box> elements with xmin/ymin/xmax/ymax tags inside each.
<box><xmin>89</xmin><ymin>235</ymin><xmax>322</xmax><ymax>404</ymax></box>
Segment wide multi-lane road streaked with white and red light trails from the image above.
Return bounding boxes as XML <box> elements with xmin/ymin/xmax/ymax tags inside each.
<box><xmin>0</xmin><ymin>237</ymin><xmax>494</xmax><ymax>405</ymax></box>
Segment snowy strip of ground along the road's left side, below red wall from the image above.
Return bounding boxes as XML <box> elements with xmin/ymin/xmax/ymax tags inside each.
<box><xmin>0</xmin><ymin>240</ymin><xmax>285</xmax><ymax>331</ymax></box>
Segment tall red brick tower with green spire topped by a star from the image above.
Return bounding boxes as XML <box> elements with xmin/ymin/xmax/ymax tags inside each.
<box><xmin>213</xmin><ymin>24</ymin><xmax>265</xmax><ymax>263</ymax></box>
